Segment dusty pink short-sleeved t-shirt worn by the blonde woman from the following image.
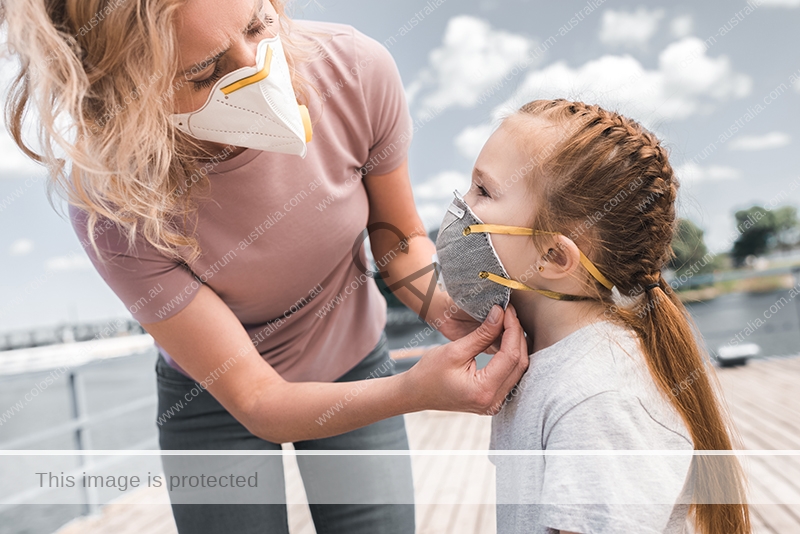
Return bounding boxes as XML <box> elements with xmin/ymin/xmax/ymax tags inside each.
<box><xmin>70</xmin><ymin>21</ymin><xmax>412</xmax><ymax>382</ymax></box>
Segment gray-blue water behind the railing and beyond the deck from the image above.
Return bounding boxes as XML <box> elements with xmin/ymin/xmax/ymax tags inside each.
<box><xmin>0</xmin><ymin>291</ymin><xmax>800</xmax><ymax>534</ymax></box>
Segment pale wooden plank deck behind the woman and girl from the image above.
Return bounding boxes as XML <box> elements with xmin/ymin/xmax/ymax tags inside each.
<box><xmin>57</xmin><ymin>358</ymin><xmax>800</xmax><ymax>534</ymax></box>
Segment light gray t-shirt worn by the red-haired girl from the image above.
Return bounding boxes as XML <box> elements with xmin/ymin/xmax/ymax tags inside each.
<box><xmin>490</xmin><ymin>321</ymin><xmax>693</xmax><ymax>534</ymax></box>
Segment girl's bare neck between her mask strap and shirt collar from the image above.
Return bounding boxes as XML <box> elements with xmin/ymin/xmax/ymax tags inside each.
<box><xmin>513</xmin><ymin>294</ymin><xmax>603</xmax><ymax>353</ymax></box>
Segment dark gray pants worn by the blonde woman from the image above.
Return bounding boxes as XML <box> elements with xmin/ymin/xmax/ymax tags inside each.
<box><xmin>156</xmin><ymin>333</ymin><xmax>415</xmax><ymax>534</ymax></box>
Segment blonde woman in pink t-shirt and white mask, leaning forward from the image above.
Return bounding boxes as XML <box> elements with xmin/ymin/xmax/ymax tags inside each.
<box><xmin>3</xmin><ymin>0</ymin><xmax>528</xmax><ymax>533</ymax></box>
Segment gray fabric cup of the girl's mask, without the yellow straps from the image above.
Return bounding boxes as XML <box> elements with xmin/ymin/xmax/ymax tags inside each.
<box><xmin>436</xmin><ymin>191</ymin><xmax>511</xmax><ymax>322</ymax></box>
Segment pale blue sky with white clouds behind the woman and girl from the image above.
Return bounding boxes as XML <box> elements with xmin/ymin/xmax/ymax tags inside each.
<box><xmin>0</xmin><ymin>0</ymin><xmax>800</xmax><ymax>330</ymax></box>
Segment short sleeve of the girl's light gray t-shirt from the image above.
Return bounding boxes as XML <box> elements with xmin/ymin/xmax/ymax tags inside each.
<box><xmin>541</xmin><ymin>391</ymin><xmax>692</xmax><ymax>533</ymax></box>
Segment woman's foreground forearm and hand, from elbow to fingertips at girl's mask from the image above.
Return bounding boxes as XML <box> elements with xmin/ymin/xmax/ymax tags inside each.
<box><xmin>247</xmin><ymin>306</ymin><xmax>528</xmax><ymax>443</ymax></box>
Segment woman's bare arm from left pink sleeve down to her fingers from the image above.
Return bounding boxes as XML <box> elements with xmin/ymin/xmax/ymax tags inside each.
<box><xmin>142</xmin><ymin>285</ymin><xmax>528</xmax><ymax>443</ymax></box>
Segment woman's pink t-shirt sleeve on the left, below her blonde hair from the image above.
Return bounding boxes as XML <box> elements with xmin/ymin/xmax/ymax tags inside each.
<box><xmin>69</xmin><ymin>205</ymin><xmax>201</xmax><ymax>324</ymax></box>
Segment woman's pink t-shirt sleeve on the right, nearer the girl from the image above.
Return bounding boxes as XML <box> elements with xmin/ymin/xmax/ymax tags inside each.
<box><xmin>351</xmin><ymin>30</ymin><xmax>413</xmax><ymax>175</ymax></box>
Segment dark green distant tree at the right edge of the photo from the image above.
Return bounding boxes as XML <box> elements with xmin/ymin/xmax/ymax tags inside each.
<box><xmin>731</xmin><ymin>206</ymin><xmax>798</xmax><ymax>266</ymax></box>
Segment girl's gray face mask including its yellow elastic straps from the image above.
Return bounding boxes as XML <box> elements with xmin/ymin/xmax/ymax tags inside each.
<box><xmin>436</xmin><ymin>191</ymin><xmax>614</xmax><ymax>321</ymax></box>
